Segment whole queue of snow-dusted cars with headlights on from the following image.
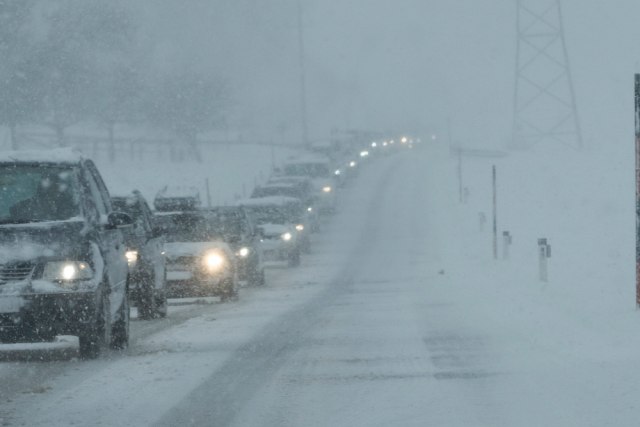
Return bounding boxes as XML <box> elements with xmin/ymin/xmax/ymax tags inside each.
<box><xmin>0</xmin><ymin>135</ymin><xmax>418</xmax><ymax>359</ymax></box>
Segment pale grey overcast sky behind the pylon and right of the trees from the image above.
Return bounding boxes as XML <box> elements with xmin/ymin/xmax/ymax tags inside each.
<box><xmin>145</xmin><ymin>0</ymin><xmax>640</xmax><ymax>146</ymax></box>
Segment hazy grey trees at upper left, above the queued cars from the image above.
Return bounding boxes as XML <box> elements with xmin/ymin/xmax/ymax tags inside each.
<box><xmin>0</xmin><ymin>0</ymin><xmax>230</xmax><ymax>156</ymax></box>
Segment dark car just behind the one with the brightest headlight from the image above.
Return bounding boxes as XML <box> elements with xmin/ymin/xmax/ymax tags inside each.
<box><xmin>206</xmin><ymin>206</ymin><xmax>265</xmax><ymax>286</ymax></box>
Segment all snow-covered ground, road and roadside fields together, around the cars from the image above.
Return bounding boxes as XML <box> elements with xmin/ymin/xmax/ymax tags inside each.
<box><xmin>0</xmin><ymin>139</ymin><xmax>640</xmax><ymax>426</ymax></box>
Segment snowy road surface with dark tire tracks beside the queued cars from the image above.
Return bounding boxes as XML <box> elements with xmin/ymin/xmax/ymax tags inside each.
<box><xmin>0</xmin><ymin>145</ymin><xmax>640</xmax><ymax>426</ymax></box>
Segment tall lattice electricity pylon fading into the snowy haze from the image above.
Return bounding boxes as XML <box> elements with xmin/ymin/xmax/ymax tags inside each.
<box><xmin>512</xmin><ymin>0</ymin><xmax>582</xmax><ymax>148</ymax></box>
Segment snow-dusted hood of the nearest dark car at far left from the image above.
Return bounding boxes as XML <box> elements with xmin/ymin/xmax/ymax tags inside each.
<box><xmin>0</xmin><ymin>219</ymin><xmax>85</xmax><ymax>264</ymax></box>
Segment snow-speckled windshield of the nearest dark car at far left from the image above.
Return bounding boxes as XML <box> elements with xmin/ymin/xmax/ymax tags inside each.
<box><xmin>0</xmin><ymin>164</ymin><xmax>80</xmax><ymax>224</ymax></box>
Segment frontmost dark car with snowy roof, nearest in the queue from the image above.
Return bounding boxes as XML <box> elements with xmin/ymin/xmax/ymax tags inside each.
<box><xmin>0</xmin><ymin>149</ymin><xmax>132</xmax><ymax>358</ymax></box>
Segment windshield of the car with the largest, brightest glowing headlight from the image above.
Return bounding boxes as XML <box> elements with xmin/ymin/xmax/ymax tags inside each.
<box><xmin>156</xmin><ymin>212</ymin><xmax>222</xmax><ymax>242</ymax></box>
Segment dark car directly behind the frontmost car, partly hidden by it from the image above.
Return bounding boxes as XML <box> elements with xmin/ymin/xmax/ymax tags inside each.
<box><xmin>111</xmin><ymin>190</ymin><xmax>167</xmax><ymax>319</ymax></box>
